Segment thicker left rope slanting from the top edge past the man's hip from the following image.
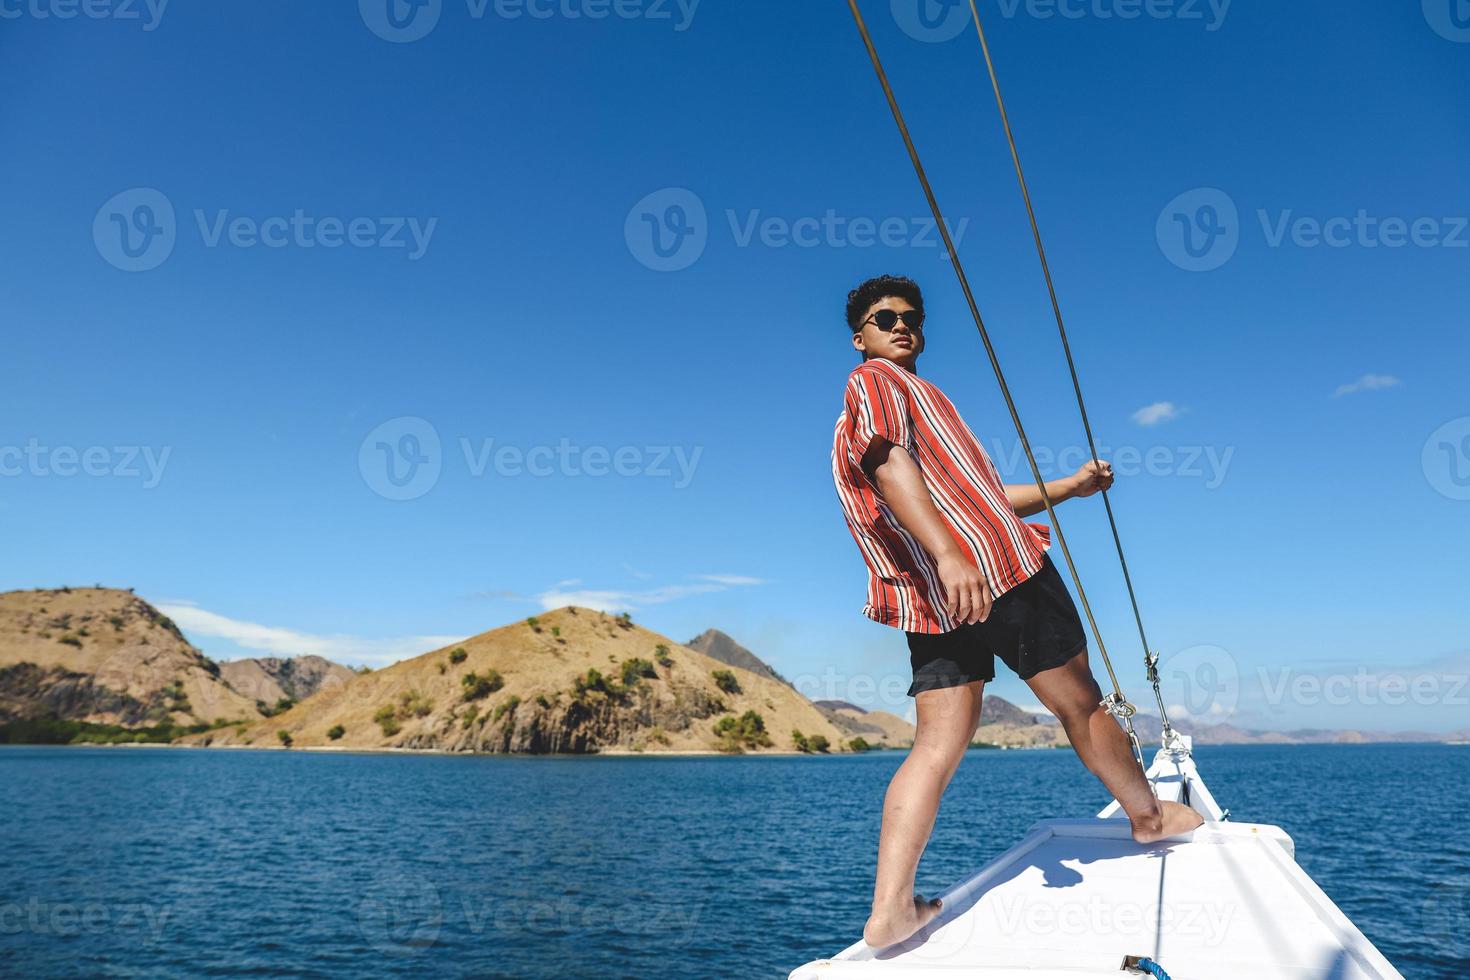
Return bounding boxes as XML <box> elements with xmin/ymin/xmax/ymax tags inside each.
<box><xmin>847</xmin><ymin>0</ymin><xmax>1145</xmax><ymax>768</ymax></box>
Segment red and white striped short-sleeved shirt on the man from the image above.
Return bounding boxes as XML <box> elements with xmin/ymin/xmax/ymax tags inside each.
<box><xmin>832</xmin><ymin>357</ymin><xmax>1051</xmax><ymax>633</ymax></box>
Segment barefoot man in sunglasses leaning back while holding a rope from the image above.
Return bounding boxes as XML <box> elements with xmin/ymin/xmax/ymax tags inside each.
<box><xmin>832</xmin><ymin>276</ymin><xmax>1202</xmax><ymax>948</ymax></box>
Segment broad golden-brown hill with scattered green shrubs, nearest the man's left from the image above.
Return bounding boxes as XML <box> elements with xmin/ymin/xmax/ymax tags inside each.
<box><xmin>185</xmin><ymin>607</ymin><xmax>848</xmax><ymax>752</ymax></box>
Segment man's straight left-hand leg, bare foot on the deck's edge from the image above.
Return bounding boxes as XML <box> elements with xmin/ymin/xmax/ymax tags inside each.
<box><xmin>863</xmin><ymin>680</ymin><xmax>985</xmax><ymax>948</ymax></box>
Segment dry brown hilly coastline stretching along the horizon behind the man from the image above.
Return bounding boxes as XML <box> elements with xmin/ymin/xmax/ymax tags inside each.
<box><xmin>0</xmin><ymin>586</ymin><xmax>1470</xmax><ymax>754</ymax></box>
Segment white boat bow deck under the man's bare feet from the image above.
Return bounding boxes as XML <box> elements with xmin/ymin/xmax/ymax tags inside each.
<box><xmin>791</xmin><ymin>751</ymin><xmax>1401</xmax><ymax>980</ymax></box>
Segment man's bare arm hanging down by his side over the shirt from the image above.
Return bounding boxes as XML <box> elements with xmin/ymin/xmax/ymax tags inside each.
<box><xmin>863</xmin><ymin>438</ymin><xmax>993</xmax><ymax>623</ymax></box>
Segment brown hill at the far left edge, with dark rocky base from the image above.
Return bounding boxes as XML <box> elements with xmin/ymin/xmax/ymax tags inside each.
<box><xmin>0</xmin><ymin>588</ymin><xmax>260</xmax><ymax>727</ymax></box>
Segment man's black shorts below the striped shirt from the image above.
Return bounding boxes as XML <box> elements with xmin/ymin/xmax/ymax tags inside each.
<box><xmin>906</xmin><ymin>557</ymin><xmax>1088</xmax><ymax>698</ymax></box>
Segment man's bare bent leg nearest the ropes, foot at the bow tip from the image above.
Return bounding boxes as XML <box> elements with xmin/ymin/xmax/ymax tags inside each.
<box><xmin>1026</xmin><ymin>651</ymin><xmax>1204</xmax><ymax>843</ymax></box>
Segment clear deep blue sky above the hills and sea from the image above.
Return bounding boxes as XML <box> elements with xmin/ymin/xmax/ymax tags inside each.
<box><xmin>0</xmin><ymin>0</ymin><xmax>1470</xmax><ymax>730</ymax></box>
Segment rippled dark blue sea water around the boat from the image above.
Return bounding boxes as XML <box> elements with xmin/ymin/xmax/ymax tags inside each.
<box><xmin>0</xmin><ymin>745</ymin><xmax>1470</xmax><ymax>979</ymax></box>
